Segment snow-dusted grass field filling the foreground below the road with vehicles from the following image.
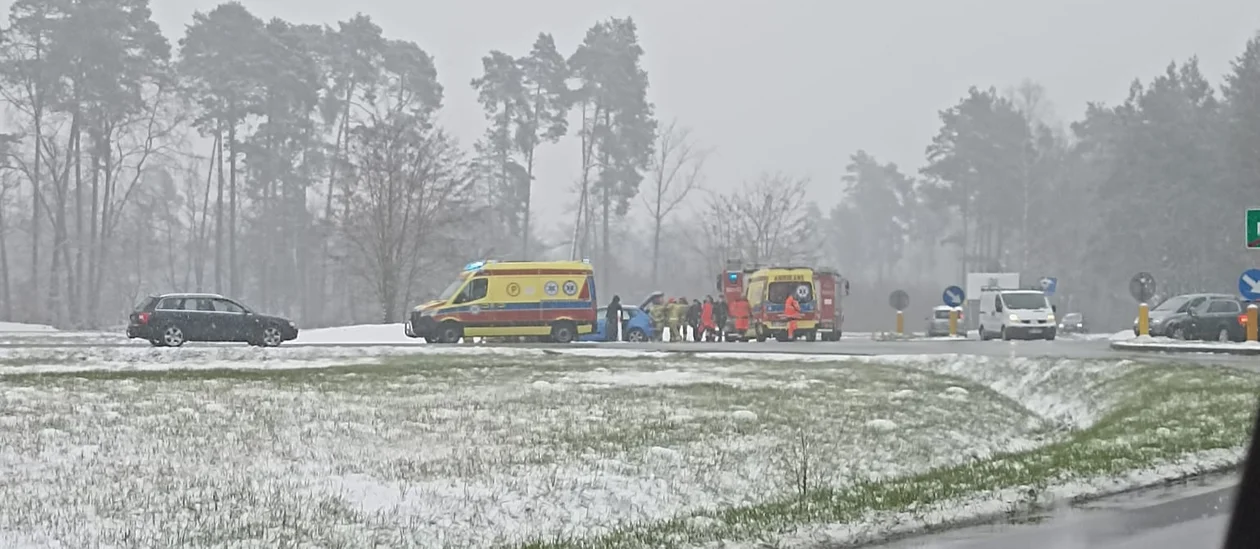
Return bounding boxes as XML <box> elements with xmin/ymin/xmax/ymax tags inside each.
<box><xmin>0</xmin><ymin>348</ymin><xmax>1256</xmax><ymax>546</ymax></box>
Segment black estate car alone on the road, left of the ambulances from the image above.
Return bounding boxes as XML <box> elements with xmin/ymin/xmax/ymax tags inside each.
<box><xmin>127</xmin><ymin>293</ymin><xmax>297</xmax><ymax>348</ymax></box>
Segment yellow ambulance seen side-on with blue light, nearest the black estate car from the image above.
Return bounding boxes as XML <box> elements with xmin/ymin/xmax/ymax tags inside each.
<box><xmin>404</xmin><ymin>261</ymin><xmax>599</xmax><ymax>344</ymax></box>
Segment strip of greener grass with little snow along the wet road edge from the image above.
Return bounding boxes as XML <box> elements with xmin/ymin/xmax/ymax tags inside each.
<box><xmin>519</xmin><ymin>365</ymin><xmax>1260</xmax><ymax>549</ymax></box>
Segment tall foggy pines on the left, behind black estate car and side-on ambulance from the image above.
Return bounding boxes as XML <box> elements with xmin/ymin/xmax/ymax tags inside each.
<box><xmin>0</xmin><ymin>0</ymin><xmax>745</xmax><ymax>327</ymax></box>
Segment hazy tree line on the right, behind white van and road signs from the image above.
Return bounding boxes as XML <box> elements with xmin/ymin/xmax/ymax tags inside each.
<box><xmin>827</xmin><ymin>35</ymin><xmax>1260</xmax><ymax>327</ymax></box>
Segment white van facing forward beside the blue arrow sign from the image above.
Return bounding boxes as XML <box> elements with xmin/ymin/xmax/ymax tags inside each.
<box><xmin>978</xmin><ymin>290</ymin><xmax>1057</xmax><ymax>341</ymax></box>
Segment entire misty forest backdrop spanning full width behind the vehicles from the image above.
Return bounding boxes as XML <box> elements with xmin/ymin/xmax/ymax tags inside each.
<box><xmin>0</xmin><ymin>0</ymin><xmax>1260</xmax><ymax>329</ymax></box>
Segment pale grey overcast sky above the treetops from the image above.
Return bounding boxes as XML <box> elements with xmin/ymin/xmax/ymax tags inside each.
<box><xmin>19</xmin><ymin>0</ymin><xmax>1260</xmax><ymax>236</ymax></box>
